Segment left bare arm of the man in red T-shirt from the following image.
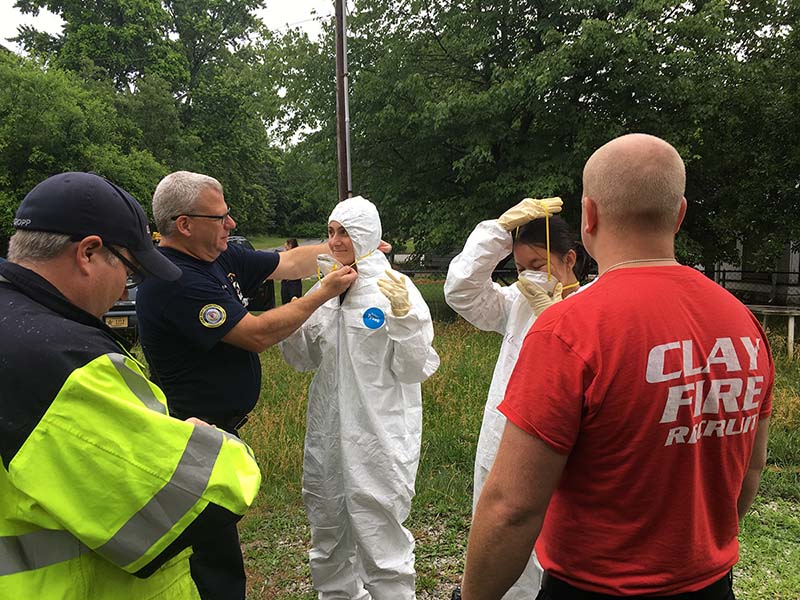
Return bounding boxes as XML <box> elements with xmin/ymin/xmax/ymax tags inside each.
<box><xmin>462</xmin><ymin>422</ymin><xmax>567</xmax><ymax>600</ymax></box>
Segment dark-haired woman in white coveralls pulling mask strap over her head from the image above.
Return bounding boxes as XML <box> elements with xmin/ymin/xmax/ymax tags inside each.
<box><xmin>444</xmin><ymin>198</ymin><xmax>586</xmax><ymax>600</ymax></box>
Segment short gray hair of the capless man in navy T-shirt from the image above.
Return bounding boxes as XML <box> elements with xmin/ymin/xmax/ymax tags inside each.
<box><xmin>153</xmin><ymin>171</ymin><xmax>222</xmax><ymax>235</ymax></box>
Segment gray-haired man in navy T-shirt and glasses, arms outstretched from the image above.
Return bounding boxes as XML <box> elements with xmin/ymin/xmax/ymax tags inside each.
<box><xmin>136</xmin><ymin>171</ymin><xmax>358</xmax><ymax>600</ymax></box>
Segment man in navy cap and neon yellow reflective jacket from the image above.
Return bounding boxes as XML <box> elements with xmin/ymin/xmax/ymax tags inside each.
<box><xmin>0</xmin><ymin>172</ymin><xmax>261</xmax><ymax>600</ymax></box>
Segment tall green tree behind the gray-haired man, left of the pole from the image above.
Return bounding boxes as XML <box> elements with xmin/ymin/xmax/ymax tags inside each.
<box><xmin>7</xmin><ymin>0</ymin><xmax>283</xmax><ymax>233</ymax></box>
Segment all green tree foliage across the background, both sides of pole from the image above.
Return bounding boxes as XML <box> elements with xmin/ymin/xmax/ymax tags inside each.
<box><xmin>0</xmin><ymin>0</ymin><xmax>800</xmax><ymax>265</ymax></box>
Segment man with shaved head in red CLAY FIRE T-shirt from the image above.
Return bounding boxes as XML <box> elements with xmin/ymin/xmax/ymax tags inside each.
<box><xmin>462</xmin><ymin>134</ymin><xmax>774</xmax><ymax>600</ymax></box>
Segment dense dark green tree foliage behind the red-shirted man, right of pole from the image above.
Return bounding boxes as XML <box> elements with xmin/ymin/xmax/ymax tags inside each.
<box><xmin>282</xmin><ymin>0</ymin><xmax>800</xmax><ymax>264</ymax></box>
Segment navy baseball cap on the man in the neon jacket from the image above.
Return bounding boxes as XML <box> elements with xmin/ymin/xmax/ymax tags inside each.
<box><xmin>14</xmin><ymin>172</ymin><xmax>181</xmax><ymax>281</ymax></box>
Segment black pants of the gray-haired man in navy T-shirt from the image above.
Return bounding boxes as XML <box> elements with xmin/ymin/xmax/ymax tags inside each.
<box><xmin>173</xmin><ymin>415</ymin><xmax>246</xmax><ymax>600</ymax></box>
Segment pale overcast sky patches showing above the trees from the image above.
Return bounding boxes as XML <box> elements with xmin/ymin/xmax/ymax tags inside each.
<box><xmin>0</xmin><ymin>0</ymin><xmax>334</xmax><ymax>50</ymax></box>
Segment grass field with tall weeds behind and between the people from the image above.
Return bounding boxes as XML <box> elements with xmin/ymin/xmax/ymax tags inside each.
<box><xmin>233</xmin><ymin>281</ymin><xmax>800</xmax><ymax>600</ymax></box>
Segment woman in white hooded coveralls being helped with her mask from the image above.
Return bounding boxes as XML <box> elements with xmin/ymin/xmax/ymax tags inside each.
<box><xmin>280</xmin><ymin>197</ymin><xmax>439</xmax><ymax>600</ymax></box>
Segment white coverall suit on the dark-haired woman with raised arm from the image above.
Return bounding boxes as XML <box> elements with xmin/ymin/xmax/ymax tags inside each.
<box><xmin>444</xmin><ymin>220</ymin><xmax>542</xmax><ymax>600</ymax></box>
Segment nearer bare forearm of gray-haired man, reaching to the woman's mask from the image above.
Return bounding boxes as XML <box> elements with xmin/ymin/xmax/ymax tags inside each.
<box><xmin>222</xmin><ymin>266</ymin><xmax>358</xmax><ymax>352</ymax></box>
